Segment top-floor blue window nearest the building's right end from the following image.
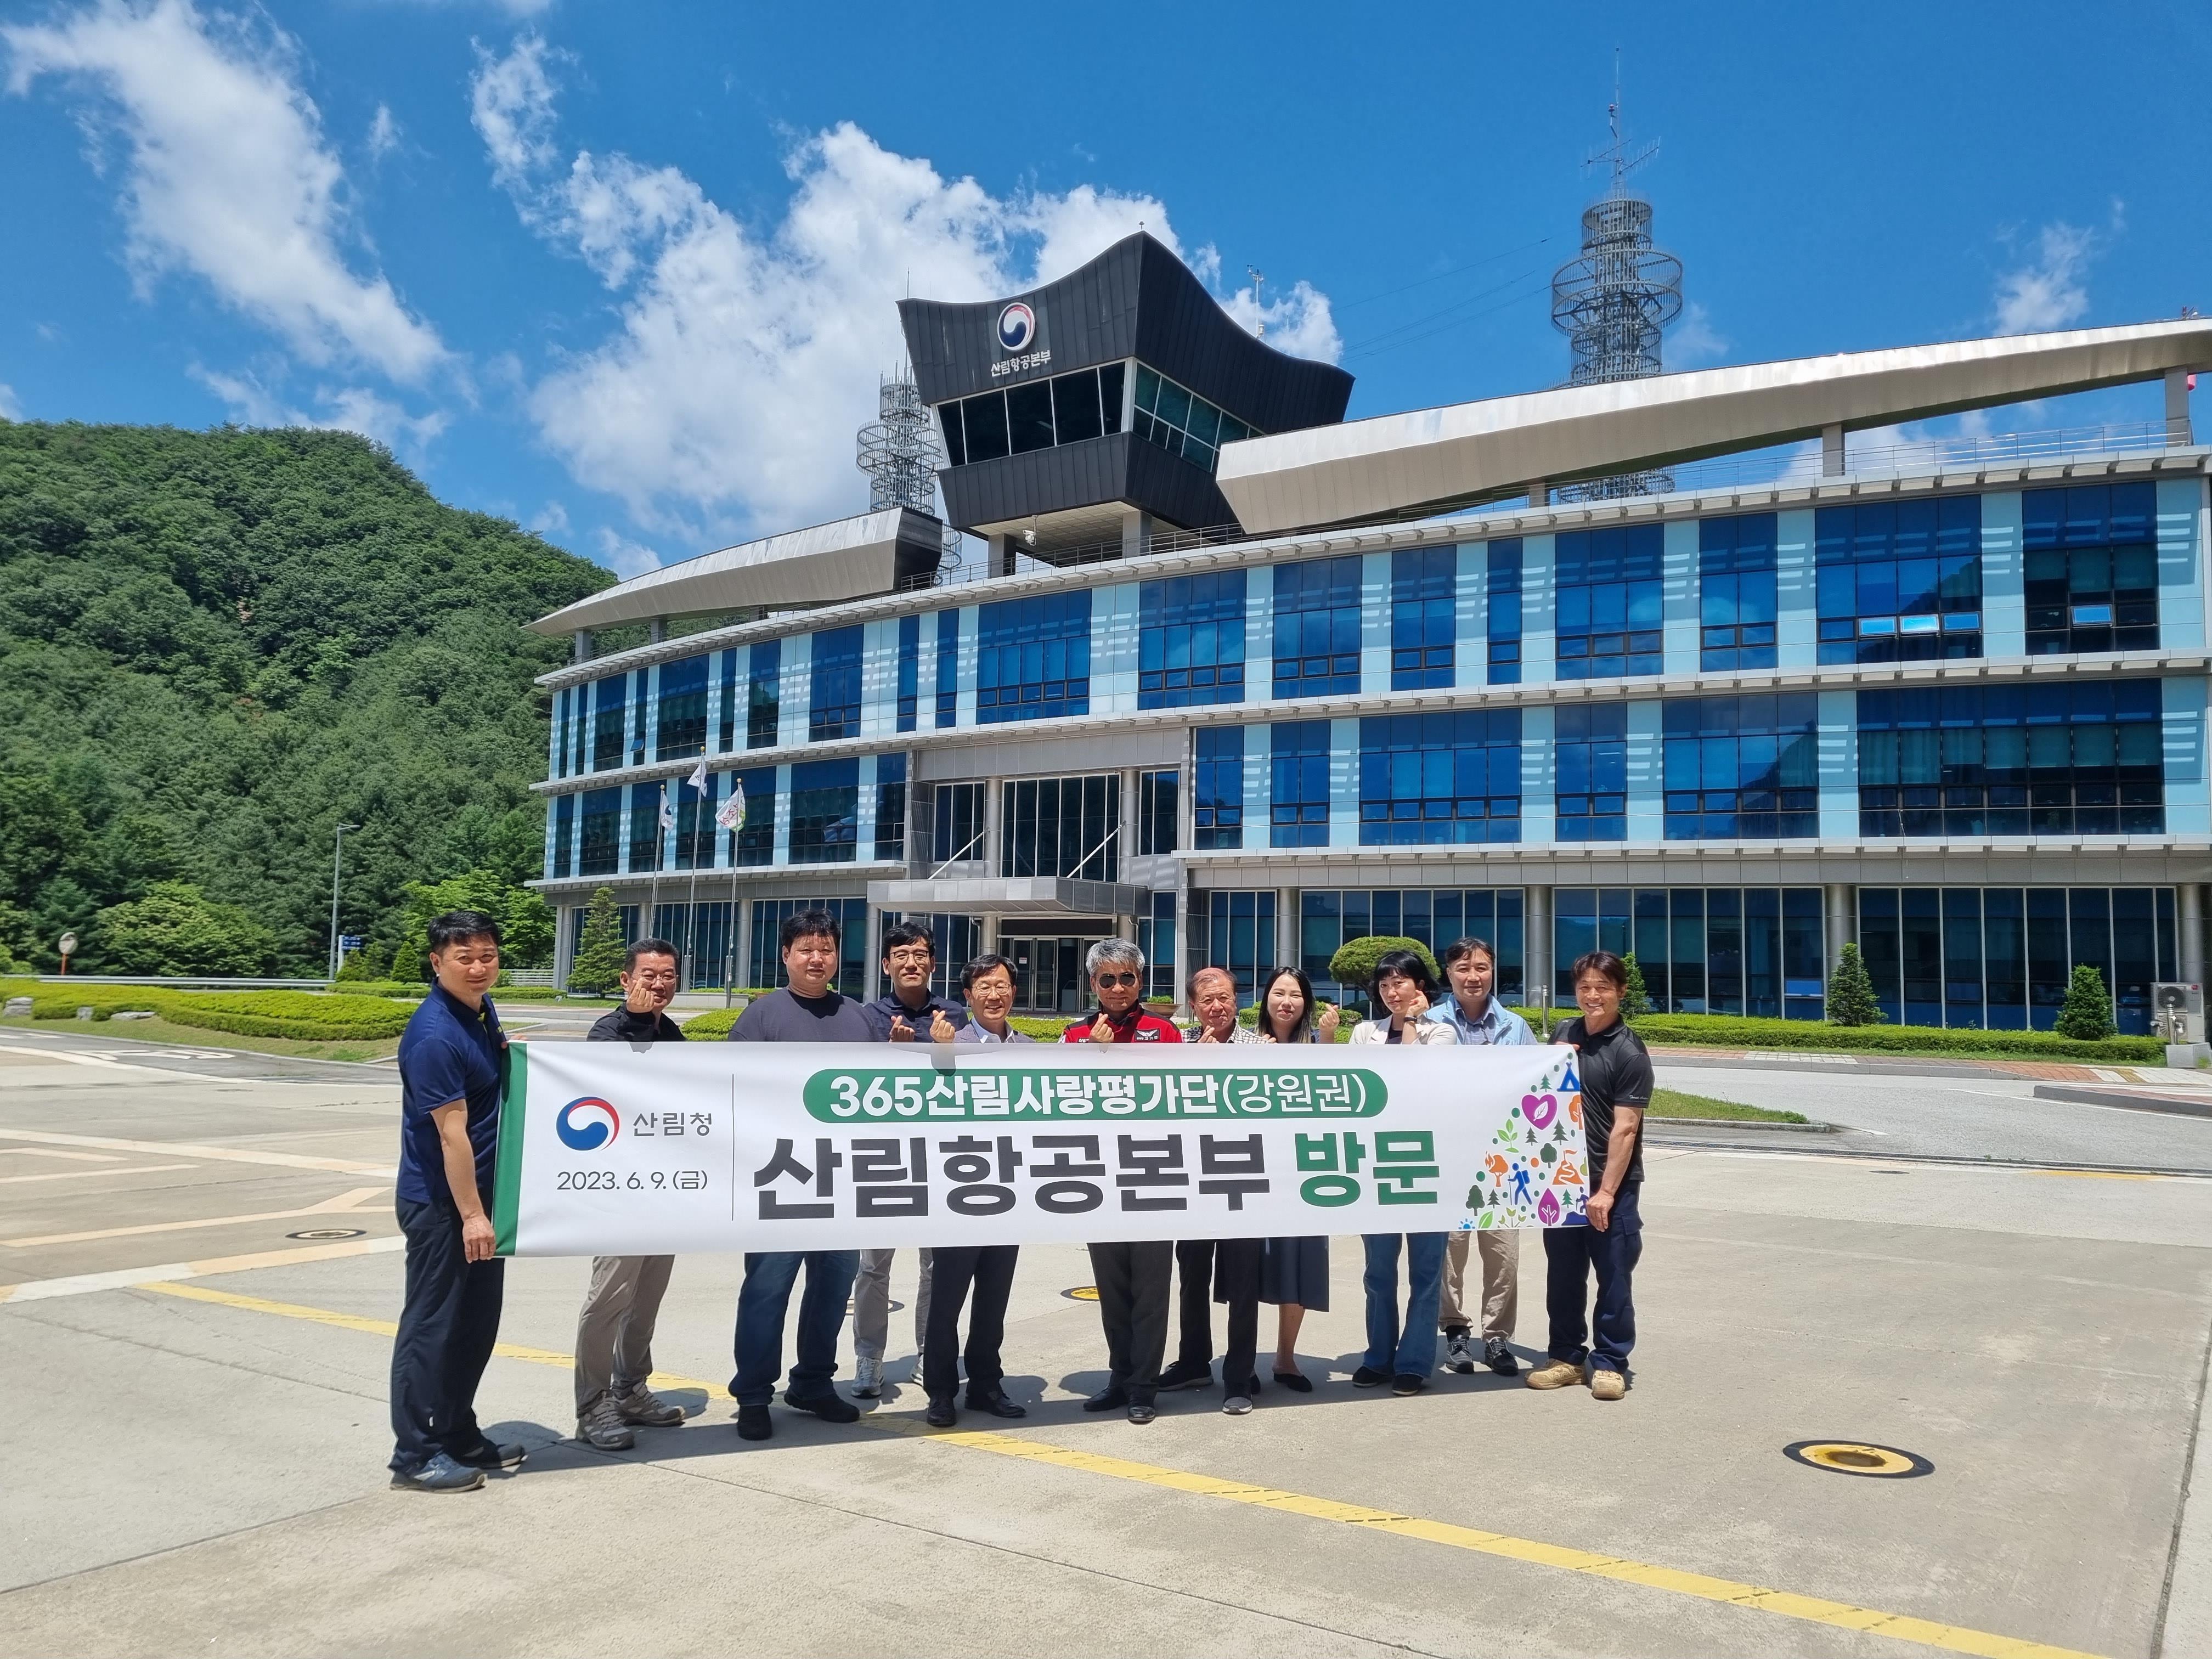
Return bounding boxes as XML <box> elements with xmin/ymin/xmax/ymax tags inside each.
<box><xmin>2019</xmin><ymin>484</ymin><xmax>2159</xmax><ymax>657</ymax></box>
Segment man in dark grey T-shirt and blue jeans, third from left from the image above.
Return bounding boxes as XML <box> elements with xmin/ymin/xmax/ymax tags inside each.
<box><xmin>730</xmin><ymin>909</ymin><xmax>876</xmax><ymax>1440</ymax></box>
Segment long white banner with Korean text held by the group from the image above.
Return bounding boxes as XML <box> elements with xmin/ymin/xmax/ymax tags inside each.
<box><xmin>493</xmin><ymin>1042</ymin><xmax>1588</xmax><ymax>1256</ymax></box>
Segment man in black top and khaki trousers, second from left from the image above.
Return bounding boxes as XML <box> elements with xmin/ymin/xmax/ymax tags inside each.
<box><xmin>575</xmin><ymin>938</ymin><xmax>684</xmax><ymax>1451</ymax></box>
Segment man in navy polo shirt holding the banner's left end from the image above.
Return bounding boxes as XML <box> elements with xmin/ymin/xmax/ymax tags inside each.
<box><xmin>392</xmin><ymin>909</ymin><xmax>522</xmax><ymax>1491</ymax></box>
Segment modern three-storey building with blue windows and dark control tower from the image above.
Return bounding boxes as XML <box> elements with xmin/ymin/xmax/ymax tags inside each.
<box><xmin>522</xmin><ymin>236</ymin><xmax>2212</xmax><ymax>1031</ymax></box>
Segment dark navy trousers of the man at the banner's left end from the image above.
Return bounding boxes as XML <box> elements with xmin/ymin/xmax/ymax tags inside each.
<box><xmin>392</xmin><ymin>1199</ymin><xmax>506</xmax><ymax>1475</ymax></box>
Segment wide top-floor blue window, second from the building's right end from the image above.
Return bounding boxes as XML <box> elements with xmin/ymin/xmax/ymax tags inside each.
<box><xmin>1814</xmin><ymin>495</ymin><xmax>1982</xmax><ymax>664</ymax></box>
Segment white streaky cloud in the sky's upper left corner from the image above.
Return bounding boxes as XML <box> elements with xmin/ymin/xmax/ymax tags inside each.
<box><xmin>0</xmin><ymin>0</ymin><xmax>447</xmax><ymax>381</ymax></box>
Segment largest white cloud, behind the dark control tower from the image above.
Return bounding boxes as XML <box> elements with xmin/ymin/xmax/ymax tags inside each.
<box><xmin>471</xmin><ymin>36</ymin><xmax>1336</xmax><ymax>538</ymax></box>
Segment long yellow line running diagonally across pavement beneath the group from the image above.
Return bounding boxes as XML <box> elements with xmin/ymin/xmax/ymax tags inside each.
<box><xmin>142</xmin><ymin>1283</ymin><xmax>2099</xmax><ymax>1659</ymax></box>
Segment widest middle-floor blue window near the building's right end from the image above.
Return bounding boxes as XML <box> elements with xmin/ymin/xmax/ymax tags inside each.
<box><xmin>1858</xmin><ymin>679</ymin><xmax>2165</xmax><ymax>836</ymax></box>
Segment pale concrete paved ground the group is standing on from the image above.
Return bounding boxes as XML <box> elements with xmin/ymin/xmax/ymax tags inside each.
<box><xmin>0</xmin><ymin>1026</ymin><xmax>2212</xmax><ymax>1659</ymax></box>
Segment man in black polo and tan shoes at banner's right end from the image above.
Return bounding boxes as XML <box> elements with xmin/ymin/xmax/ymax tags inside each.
<box><xmin>1528</xmin><ymin>951</ymin><xmax>1652</xmax><ymax>1400</ymax></box>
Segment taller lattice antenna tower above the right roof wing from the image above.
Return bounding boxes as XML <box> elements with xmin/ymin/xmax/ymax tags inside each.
<box><xmin>1550</xmin><ymin>49</ymin><xmax>1681</xmax><ymax>500</ymax></box>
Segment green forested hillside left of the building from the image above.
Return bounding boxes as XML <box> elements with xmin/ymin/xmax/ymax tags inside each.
<box><xmin>0</xmin><ymin>420</ymin><xmax>613</xmax><ymax>973</ymax></box>
